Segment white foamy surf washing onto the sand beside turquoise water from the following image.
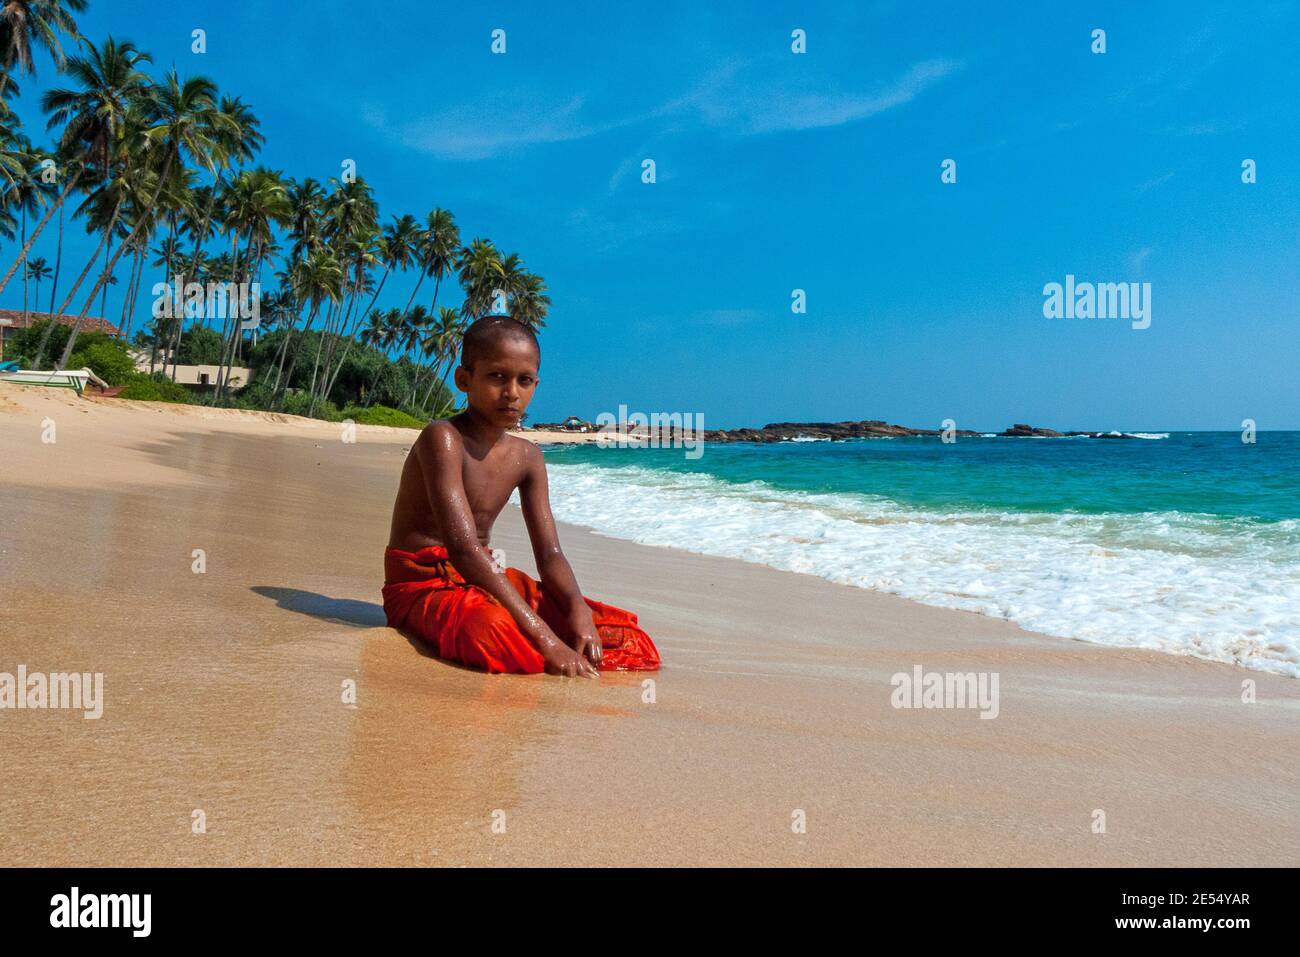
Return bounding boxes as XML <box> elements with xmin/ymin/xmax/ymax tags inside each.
<box><xmin>530</xmin><ymin>463</ymin><xmax>1300</xmax><ymax>677</ymax></box>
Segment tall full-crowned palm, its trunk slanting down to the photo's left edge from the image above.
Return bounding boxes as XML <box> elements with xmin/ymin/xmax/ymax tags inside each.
<box><xmin>0</xmin><ymin>36</ymin><xmax>151</xmax><ymax>293</ymax></box>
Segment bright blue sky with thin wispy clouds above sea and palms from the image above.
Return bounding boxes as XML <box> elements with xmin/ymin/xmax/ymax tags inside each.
<box><xmin>4</xmin><ymin>0</ymin><xmax>1300</xmax><ymax>429</ymax></box>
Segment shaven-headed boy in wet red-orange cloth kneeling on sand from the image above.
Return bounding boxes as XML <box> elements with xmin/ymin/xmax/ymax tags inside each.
<box><xmin>384</xmin><ymin>316</ymin><xmax>659</xmax><ymax>677</ymax></box>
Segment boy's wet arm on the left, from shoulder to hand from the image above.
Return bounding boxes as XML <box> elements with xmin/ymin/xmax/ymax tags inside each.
<box><xmin>411</xmin><ymin>424</ymin><xmax>594</xmax><ymax>676</ymax></box>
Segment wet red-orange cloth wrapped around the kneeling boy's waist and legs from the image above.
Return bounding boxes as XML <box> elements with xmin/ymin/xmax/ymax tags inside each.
<box><xmin>384</xmin><ymin>546</ymin><xmax>659</xmax><ymax>675</ymax></box>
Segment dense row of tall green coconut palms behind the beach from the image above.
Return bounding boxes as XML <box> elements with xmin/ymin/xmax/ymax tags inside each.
<box><xmin>0</xmin><ymin>0</ymin><xmax>550</xmax><ymax>415</ymax></box>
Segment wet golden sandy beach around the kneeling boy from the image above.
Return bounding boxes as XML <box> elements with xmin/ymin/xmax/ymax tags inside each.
<box><xmin>0</xmin><ymin>385</ymin><xmax>1300</xmax><ymax>866</ymax></box>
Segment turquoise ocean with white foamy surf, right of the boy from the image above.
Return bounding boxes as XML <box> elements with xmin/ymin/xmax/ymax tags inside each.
<box><xmin>530</xmin><ymin>432</ymin><xmax>1300</xmax><ymax>677</ymax></box>
